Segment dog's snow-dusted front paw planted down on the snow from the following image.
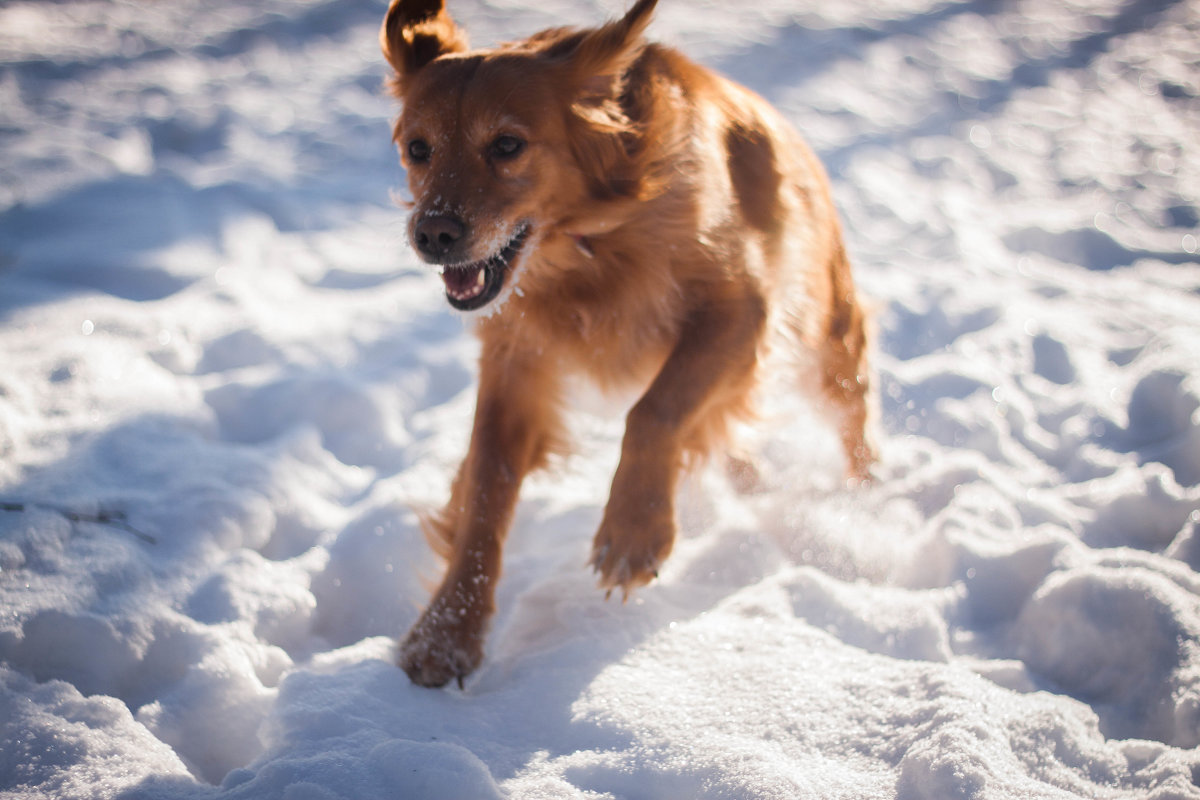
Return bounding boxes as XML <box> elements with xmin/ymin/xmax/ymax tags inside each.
<box><xmin>396</xmin><ymin>606</ymin><xmax>484</xmax><ymax>688</ymax></box>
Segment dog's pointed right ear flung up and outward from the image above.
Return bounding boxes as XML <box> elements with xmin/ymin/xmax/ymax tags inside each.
<box><xmin>550</xmin><ymin>0</ymin><xmax>658</xmax><ymax>102</ymax></box>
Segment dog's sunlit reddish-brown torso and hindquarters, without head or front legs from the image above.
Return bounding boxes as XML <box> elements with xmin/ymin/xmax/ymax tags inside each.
<box><xmin>535</xmin><ymin>43</ymin><xmax>874</xmax><ymax>470</ymax></box>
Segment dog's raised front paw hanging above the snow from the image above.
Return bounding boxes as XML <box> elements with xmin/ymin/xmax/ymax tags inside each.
<box><xmin>590</xmin><ymin>513</ymin><xmax>676</xmax><ymax>600</ymax></box>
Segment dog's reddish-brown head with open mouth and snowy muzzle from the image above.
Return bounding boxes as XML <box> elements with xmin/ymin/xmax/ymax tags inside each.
<box><xmin>380</xmin><ymin>0</ymin><xmax>656</xmax><ymax>311</ymax></box>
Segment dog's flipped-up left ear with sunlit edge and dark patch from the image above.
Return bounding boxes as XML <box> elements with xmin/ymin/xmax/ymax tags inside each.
<box><xmin>379</xmin><ymin>0</ymin><xmax>468</xmax><ymax>95</ymax></box>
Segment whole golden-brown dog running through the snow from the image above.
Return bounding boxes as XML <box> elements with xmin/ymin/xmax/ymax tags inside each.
<box><xmin>380</xmin><ymin>0</ymin><xmax>874</xmax><ymax>686</ymax></box>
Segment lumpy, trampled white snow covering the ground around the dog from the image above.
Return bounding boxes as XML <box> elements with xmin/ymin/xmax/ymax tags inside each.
<box><xmin>0</xmin><ymin>0</ymin><xmax>1200</xmax><ymax>800</ymax></box>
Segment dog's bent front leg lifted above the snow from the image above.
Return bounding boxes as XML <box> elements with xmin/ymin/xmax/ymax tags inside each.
<box><xmin>592</xmin><ymin>294</ymin><xmax>766</xmax><ymax>596</ymax></box>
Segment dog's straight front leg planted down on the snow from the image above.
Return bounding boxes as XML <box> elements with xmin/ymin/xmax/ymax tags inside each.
<box><xmin>400</xmin><ymin>350</ymin><xmax>557</xmax><ymax>686</ymax></box>
